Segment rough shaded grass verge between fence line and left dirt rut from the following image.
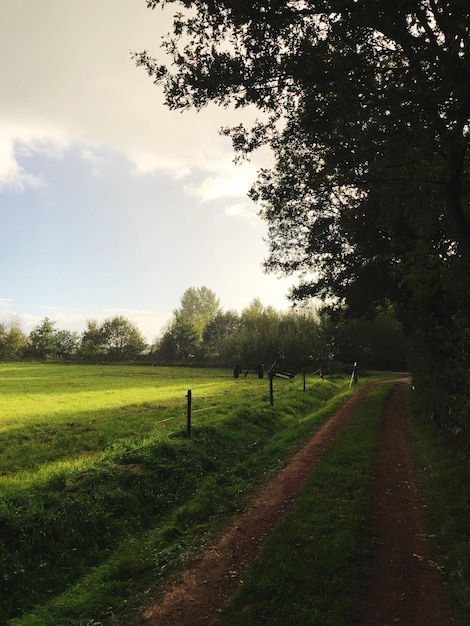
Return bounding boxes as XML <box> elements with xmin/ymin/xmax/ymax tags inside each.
<box><xmin>0</xmin><ymin>366</ymin><xmax>362</xmax><ymax>626</ymax></box>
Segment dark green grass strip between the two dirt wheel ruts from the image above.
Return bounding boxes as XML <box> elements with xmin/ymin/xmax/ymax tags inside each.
<box><xmin>217</xmin><ymin>385</ymin><xmax>390</xmax><ymax>626</ymax></box>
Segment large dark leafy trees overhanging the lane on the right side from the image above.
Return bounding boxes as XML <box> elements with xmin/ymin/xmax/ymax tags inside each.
<box><xmin>135</xmin><ymin>0</ymin><xmax>470</xmax><ymax>441</ymax></box>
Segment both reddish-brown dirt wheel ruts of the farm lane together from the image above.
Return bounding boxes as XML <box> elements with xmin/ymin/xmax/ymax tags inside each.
<box><xmin>139</xmin><ymin>383</ymin><xmax>452</xmax><ymax>626</ymax></box>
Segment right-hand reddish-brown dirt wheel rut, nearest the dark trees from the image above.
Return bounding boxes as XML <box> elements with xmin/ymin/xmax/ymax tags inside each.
<box><xmin>364</xmin><ymin>383</ymin><xmax>454</xmax><ymax>626</ymax></box>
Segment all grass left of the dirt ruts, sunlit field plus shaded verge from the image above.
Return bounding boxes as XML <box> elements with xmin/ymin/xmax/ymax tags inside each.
<box><xmin>0</xmin><ymin>364</ymin><xmax>364</xmax><ymax>626</ymax></box>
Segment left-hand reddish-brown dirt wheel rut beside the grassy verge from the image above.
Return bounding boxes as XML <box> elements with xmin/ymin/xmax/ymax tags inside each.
<box><xmin>143</xmin><ymin>383</ymin><xmax>381</xmax><ymax>626</ymax></box>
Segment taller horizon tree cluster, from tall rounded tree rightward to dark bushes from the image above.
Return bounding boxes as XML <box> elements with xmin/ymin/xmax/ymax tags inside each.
<box><xmin>152</xmin><ymin>287</ymin><xmax>405</xmax><ymax>369</ymax></box>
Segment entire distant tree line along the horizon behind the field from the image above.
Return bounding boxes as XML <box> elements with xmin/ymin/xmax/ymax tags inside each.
<box><xmin>0</xmin><ymin>287</ymin><xmax>405</xmax><ymax>370</ymax></box>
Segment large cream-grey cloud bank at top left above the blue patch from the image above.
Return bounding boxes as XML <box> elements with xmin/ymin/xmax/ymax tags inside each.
<box><xmin>0</xmin><ymin>0</ymin><xmax>258</xmax><ymax>194</ymax></box>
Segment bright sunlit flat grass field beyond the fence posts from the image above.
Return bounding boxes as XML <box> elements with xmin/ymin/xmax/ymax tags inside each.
<box><xmin>0</xmin><ymin>364</ymin><xmax>250</xmax><ymax>482</ymax></box>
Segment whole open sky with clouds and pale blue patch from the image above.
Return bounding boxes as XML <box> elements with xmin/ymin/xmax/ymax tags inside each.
<box><xmin>0</xmin><ymin>0</ymin><xmax>292</xmax><ymax>342</ymax></box>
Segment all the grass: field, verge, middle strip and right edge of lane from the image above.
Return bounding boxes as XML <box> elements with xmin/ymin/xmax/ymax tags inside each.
<box><xmin>0</xmin><ymin>364</ymin><xmax>470</xmax><ymax>626</ymax></box>
